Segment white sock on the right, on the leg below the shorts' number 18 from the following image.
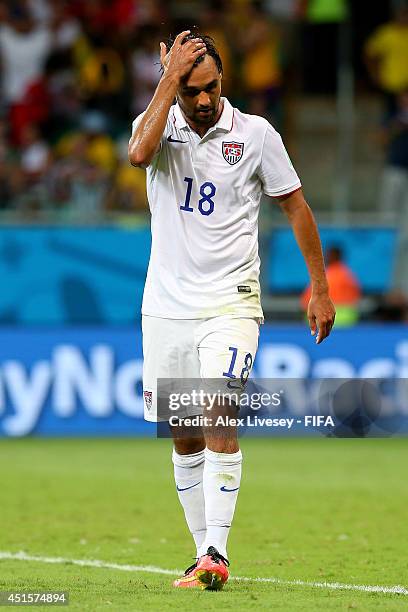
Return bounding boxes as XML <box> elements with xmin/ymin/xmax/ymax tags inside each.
<box><xmin>200</xmin><ymin>448</ymin><xmax>242</xmax><ymax>558</ymax></box>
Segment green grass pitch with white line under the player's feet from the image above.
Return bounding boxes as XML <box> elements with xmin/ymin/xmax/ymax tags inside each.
<box><xmin>0</xmin><ymin>438</ymin><xmax>408</xmax><ymax>612</ymax></box>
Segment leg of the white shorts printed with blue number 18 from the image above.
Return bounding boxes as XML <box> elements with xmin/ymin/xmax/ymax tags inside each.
<box><xmin>198</xmin><ymin>316</ymin><xmax>259</xmax><ymax>389</ymax></box>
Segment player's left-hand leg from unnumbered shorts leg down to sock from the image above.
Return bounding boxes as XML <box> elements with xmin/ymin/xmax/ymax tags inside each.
<box><xmin>142</xmin><ymin>316</ymin><xmax>206</xmax><ymax>552</ymax></box>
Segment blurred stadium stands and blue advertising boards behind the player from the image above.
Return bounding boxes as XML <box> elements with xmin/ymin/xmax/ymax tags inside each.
<box><xmin>0</xmin><ymin>0</ymin><xmax>408</xmax><ymax>436</ymax></box>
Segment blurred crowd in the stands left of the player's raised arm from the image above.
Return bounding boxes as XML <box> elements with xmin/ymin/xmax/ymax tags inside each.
<box><xmin>0</xmin><ymin>0</ymin><xmax>162</xmax><ymax>220</ymax></box>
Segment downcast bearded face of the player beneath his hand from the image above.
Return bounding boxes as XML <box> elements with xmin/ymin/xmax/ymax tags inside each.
<box><xmin>177</xmin><ymin>55</ymin><xmax>221</xmax><ymax>126</ymax></box>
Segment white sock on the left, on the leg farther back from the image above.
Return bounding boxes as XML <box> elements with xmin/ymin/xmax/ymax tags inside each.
<box><xmin>172</xmin><ymin>449</ymin><xmax>206</xmax><ymax>557</ymax></box>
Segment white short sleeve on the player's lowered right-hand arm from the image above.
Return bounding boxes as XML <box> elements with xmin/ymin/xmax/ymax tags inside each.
<box><xmin>258</xmin><ymin>123</ymin><xmax>302</xmax><ymax>197</ymax></box>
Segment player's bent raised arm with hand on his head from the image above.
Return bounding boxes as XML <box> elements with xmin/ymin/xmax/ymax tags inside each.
<box><xmin>128</xmin><ymin>30</ymin><xmax>206</xmax><ymax>168</ymax></box>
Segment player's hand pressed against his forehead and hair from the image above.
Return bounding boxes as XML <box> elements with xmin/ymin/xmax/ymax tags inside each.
<box><xmin>160</xmin><ymin>30</ymin><xmax>207</xmax><ymax>79</ymax></box>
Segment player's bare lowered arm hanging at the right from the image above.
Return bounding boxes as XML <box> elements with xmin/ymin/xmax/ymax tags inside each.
<box><xmin>279</xmin><ymin>189</ymin><xmax>336</xmax><ymax>344</ymax></box>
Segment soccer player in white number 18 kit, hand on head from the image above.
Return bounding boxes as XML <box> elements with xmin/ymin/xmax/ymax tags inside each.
<box><xmin>129</xmin><ymin>31</ymin><xmax>335</xmax><ymax>589</ymax></box>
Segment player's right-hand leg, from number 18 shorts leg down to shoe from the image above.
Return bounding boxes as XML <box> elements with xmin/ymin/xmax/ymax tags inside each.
<box><xmin>194</xmin><ymin>317</ymin><xmax>259</xmax><ymax>588</ymax></box>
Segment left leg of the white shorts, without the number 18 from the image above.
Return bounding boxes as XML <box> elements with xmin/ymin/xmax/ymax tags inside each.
<box><xmin>142</xmin><ymin>315</ymin><xmax>200</xmax><ymax>421</ymax></box>
